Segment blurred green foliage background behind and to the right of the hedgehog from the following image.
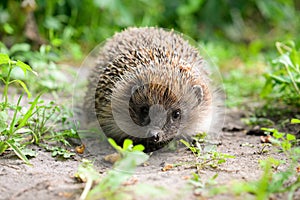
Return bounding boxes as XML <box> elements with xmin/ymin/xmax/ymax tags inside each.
<box><xmin>0</xmin><ymin>0</ymin><xmax>300</xmax><ymax>106</ymax></box>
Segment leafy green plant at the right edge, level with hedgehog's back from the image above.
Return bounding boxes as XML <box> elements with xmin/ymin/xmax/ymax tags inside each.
<box><xmin>261</xmin><ymin>41</ymin><xmax>300</xmax><ymax>108</ymax></box>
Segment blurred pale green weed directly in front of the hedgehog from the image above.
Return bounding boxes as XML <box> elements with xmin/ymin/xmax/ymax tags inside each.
<box><xmin>76</xmin><ymin>139</ymin><xmax>149</xmax><ymax>199</ymax></box>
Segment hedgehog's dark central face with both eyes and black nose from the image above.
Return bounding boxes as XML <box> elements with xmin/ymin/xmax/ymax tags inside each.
<box><xmin>129</xmin><ymin>84</ymin><xmax>190</xmax><ymax>143</ymax></box>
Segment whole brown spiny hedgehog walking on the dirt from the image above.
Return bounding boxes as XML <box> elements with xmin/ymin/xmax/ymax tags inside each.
<box><xmin>84</xmin><ymin>27</ymin><xmax>220</xmax><ymax>152</ymax></box>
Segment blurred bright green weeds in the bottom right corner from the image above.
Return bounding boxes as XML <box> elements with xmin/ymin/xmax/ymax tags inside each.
<box><xmin>211</xmin><ymin>119</ymin><xmax>300</xmax><ymax>200</ymax></box>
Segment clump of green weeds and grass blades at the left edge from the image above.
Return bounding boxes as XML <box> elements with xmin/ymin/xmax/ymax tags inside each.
<box><xmin>0</xmin><ymin>54</ymin><xmax>78</xmax><ymax>164</ymax></box>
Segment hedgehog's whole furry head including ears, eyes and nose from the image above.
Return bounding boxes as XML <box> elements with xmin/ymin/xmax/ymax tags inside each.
<box><xmin>108</xmin><ymin>68</ymin><xmax>205</xmax><ymax>149</ymax></box>
